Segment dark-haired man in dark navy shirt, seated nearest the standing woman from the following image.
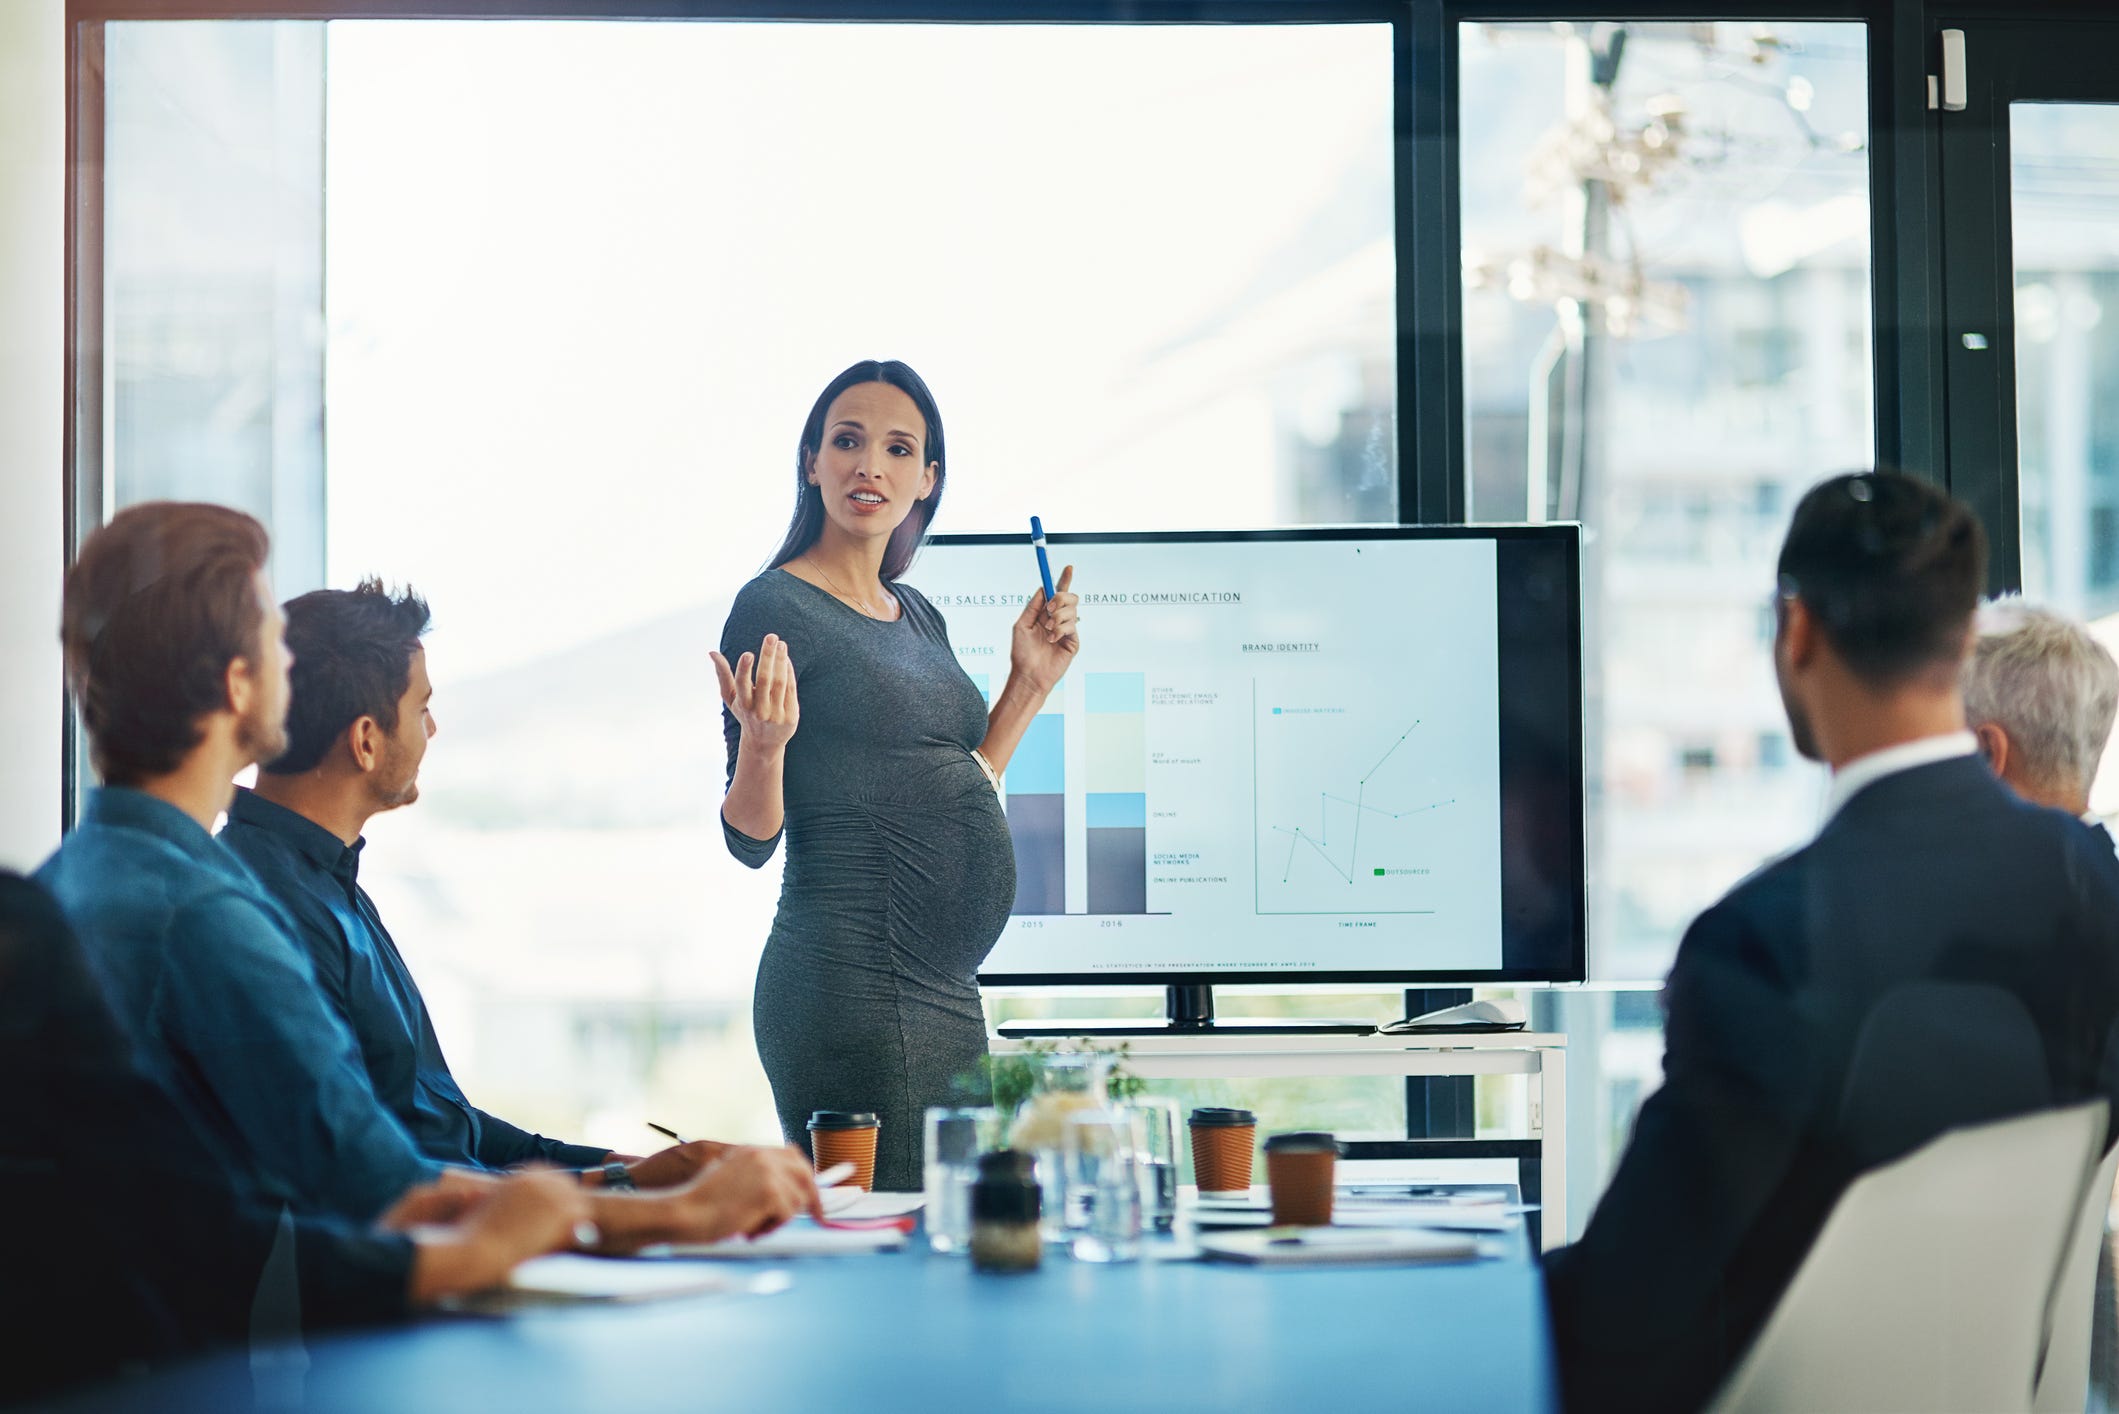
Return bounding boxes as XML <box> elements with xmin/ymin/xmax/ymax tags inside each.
<box><xmin>220</xmin><ymin>579</ymin><xmax>725</xmax><ymax>1187</ymax></box>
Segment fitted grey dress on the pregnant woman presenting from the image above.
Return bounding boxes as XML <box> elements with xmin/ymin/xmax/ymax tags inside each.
<box><xmin>720</xmin><ymin>570</ymin><xmax>1015</xmax><ymax>1189</ymax></box>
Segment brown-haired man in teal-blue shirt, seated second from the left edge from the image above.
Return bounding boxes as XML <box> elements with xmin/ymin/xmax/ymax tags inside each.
<box><xmin>38</xmin><ymin>502</ymin><xmax>816</xmax><ymax>1249</ymax></box>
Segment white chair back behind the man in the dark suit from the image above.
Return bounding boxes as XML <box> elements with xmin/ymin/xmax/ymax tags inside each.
<box><xmin>1712</xmin><ymin>1100</ymin><xmax>2106</xmax><ymax>1414</ymax></box>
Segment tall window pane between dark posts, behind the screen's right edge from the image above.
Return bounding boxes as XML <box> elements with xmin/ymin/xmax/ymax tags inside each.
<box><xmin>1460</xmin><ymin>21</ymin><xmax>1873</xmax><ymax>979</ymax></box>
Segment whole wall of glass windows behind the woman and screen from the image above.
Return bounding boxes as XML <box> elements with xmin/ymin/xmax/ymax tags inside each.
<box><xmin>86</xmin><ymin>4</ymin><xmax>1941</xmax><ymax>1221</ymax></box>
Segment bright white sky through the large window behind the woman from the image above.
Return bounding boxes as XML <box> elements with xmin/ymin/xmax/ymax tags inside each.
<box><xmin>326</xmin><ymin>21</ymin><xmax>1392</xmax><ymax>674</ymax></box>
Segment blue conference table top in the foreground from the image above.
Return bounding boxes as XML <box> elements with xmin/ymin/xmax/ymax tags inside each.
<box><xmin>59</xmin><ymin>1230</ymin><xmax>1557</xmax><ymax>1414</ymax></box>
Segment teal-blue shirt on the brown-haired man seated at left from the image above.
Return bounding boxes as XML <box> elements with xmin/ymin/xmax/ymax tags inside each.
<box><xmin>36</xmin><ymin>786</ymin><xmax>439</xmax><ymax>1221</ymax></box>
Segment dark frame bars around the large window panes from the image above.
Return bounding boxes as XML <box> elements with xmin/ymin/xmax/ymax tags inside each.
<box><xmin>61</xmin><ymin>0</ymin><xmax>2008</xmax><ymax>805</ymax></box>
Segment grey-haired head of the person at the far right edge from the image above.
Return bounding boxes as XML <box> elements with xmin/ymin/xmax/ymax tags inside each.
<box><xmin>1964</xmin><ymin>596</ymin><xmax>2119</xmax><ymax>818</ymax></box>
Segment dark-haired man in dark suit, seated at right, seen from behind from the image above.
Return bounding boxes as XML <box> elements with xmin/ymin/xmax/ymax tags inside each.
<box><xmin>1547</xmin><ymin>473</ymin><xmax>2119</xmax><ymax>1414</ymax></box>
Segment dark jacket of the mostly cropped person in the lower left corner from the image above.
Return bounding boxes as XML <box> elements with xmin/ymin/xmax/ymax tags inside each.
<box><xmin>0</xmin><ymin>871</ymin><xmax>413</xmax><ymax>1403</ymax></box>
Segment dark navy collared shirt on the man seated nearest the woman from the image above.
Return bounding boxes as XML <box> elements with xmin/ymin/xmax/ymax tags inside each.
<box><xmin>220</xmin><ymin>791</ymin><xmax>608</xmax><ymax>1168</ymax></box>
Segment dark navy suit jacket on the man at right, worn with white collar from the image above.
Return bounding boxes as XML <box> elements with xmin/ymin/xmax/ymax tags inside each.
<box><xmin>1545</xmin><ymin>757</ymin><xmax>2119</xmax><ymax>1414</ymax></box>
